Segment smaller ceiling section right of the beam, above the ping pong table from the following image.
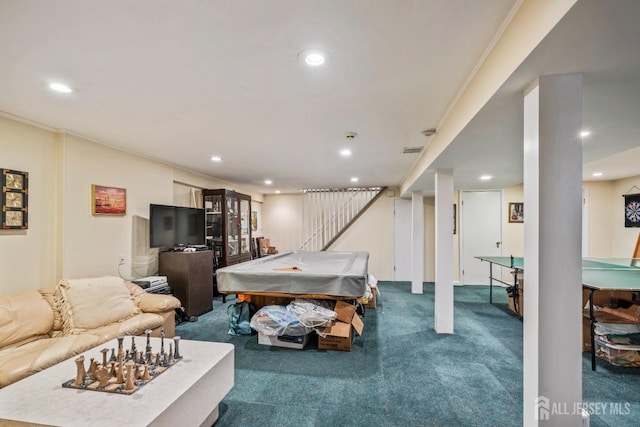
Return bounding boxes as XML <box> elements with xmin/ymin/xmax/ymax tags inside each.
<box><xmin>412</xmin><ymin>0</ymin><xmax>640</xmax><ymax>194</ymax></box>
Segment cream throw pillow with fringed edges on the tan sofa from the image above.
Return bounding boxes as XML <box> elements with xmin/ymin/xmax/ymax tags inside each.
<box><xmin>58</xmin><ymin>277</ymin><xmax>140</xmax><ymax>334</ymax></box>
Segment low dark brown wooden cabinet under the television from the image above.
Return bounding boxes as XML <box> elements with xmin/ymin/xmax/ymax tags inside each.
<box><xmin>160</xmin><ymin>251</ymin><xmax>213</xmax><ymax>316</ymax></box>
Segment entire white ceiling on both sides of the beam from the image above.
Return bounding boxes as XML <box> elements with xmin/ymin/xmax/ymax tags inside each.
<box><xmin>0</xmin><ymin>0</ymin><xmax>640</xmax><ymax>193</ymax></box>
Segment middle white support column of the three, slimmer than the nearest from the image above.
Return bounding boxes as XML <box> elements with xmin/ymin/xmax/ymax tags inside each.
<box><xmin>434</xmin><ymin>169</ymin><xmax>453</xmax><ymax>334</ymax></box>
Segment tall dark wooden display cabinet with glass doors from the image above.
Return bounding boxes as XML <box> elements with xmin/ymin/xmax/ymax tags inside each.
<box><xmin>202</xmin><ymin>189</ymin><xmax>251</xmax><ymax>268</ymax></box>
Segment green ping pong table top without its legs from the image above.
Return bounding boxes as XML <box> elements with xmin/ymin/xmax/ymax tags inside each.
<box><xmin>476</xmin><ymin>256</ymin><xmax>640</xmax><ymax>291</ymax></box>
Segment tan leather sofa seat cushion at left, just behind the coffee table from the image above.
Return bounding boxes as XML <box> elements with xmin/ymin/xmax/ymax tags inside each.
<box><xmin>0</xmin><ymin>334</ymin><xmax>100</xmax><ymax>390</ymax></box>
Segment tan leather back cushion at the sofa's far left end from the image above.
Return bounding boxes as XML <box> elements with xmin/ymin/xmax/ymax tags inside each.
<box><xmin>0</xmin><ymin>291</ymin><xmax>53</xmax><ymax>348</ymax></box>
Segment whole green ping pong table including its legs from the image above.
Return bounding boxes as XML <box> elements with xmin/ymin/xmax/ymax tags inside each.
<box><xmin>475</xmin><ymin>256</ymin><xmax>640</xmax><ymax>371</ymax></box>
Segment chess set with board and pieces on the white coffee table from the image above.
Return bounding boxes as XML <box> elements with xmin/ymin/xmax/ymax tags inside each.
<box><xmin>62</xmin><ymin>329</ymin><xmax>182</xmax><ymax>394</ymax></box>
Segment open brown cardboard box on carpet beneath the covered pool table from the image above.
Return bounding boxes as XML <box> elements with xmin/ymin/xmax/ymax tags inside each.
<box><xmin>318</xmin><ymin>301</ymin><xmax>364</xmax><ymax>351</ymax></box>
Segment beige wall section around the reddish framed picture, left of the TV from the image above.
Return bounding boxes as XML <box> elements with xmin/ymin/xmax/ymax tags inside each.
<box><xmin>62</xmin><ymin>135</ymin><xmax>173</xmax><ymax>278</ymax></box>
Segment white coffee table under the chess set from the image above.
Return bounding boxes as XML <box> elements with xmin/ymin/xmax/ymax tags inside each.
<box><xmin>0</xmin><ymin>337</ymin><xmax>234</xmax><ymax>427</ymax></box>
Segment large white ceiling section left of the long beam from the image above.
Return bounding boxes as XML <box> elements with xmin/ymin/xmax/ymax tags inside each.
<box><xmin>0</xmin><ymin>0</ymin><xmax>515</xmax><ymax>192</ymax></box>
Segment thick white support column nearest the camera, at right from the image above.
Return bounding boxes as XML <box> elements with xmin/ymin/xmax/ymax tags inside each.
<box><xmin>523</xmin><ymin>74</ymin><xmax>582</xmax><ymax>427</ymax></box>
